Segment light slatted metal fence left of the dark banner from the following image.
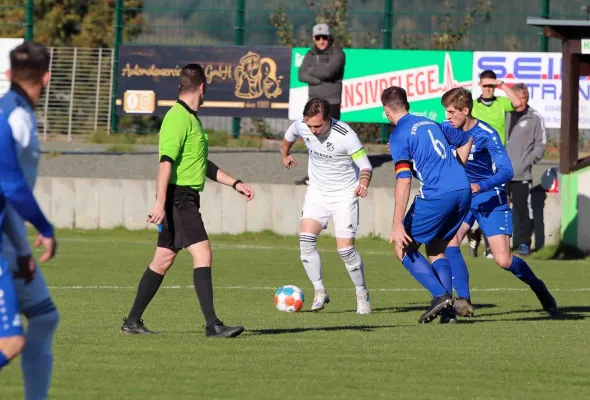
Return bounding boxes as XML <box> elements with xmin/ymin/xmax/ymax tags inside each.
<box><xmin>37</xmin><ymin>47</ymin><xmax>113</xmax><ymax>141</ymax></box>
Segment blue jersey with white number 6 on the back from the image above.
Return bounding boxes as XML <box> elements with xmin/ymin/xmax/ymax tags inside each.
<box><xmin>389</xmin><ymin>114</ymin><xmax>470</xmax><ymax>198</ymax></box>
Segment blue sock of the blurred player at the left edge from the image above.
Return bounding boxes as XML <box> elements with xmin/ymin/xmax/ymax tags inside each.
<box><xmin>21</xmin><ymin>308</ymin><xmax>59</xmax><ymax>400</ymax></box>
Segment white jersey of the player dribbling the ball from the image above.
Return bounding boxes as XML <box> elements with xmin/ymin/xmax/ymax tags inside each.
<box><xmin>285</xmin><ymin>118</ymin><xmax>364</xmax><ymax>196</ymax></box>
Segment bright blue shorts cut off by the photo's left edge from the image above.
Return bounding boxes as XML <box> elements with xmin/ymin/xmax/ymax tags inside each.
<box><xmin>0</xmin><ymin>255</ymin><xmax>23</xmax><ymax>338</ymax></box>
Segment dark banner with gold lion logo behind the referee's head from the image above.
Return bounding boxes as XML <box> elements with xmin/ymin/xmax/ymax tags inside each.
<box><xmin>117</xmin><ymin>46</ymin><xmax>291</xmax><ymax>118</ymax></box>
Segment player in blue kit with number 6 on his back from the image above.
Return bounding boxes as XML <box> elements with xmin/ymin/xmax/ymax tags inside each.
<box><xmin>381</xmin><ymin>86</ymin><xmax>472</xmax><ymax>323</ymax></box>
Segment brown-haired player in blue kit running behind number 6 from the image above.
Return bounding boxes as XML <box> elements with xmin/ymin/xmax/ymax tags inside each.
<box><xmin>442</xmin><ymin>88</ymin><xmax>557</xmax><ymax>318</ymax></box>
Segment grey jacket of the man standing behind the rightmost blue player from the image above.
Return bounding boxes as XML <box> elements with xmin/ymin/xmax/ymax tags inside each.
<box><xmin>506</xmin><ymin>107</ymin><xmax>547</xmax><ymax>181</ymax></box>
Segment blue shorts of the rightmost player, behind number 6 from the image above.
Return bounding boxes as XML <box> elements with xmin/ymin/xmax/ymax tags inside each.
<box><xmin>465</xmin><ymin>190</ymin><xmax>512</xmax><ymax>237</ymax></box>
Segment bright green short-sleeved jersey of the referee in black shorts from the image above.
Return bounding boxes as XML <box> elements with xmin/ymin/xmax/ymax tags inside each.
<box><xmin>159</xmin><ymin>100</ymin><xmax>209</xmax><ymax>192</ymax></box>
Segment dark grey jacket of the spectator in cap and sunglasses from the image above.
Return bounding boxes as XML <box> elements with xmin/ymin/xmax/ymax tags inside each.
<box><xmin>299</xmin><ymin>43</ymin><xmax>345</xmax><ymax>104</ymax></box>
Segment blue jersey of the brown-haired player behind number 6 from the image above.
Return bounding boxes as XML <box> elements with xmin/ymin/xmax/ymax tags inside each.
<box><xmin>442</xmin><ymin>120</ymin><xmax>514</xmax><ymax>195</ymax></box>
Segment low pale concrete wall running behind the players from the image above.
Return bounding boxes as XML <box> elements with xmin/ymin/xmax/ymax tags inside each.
<box><xmin>35</xmin><ymin>177</ymin><xmax>561</xmax><ymax>244</ymax></box>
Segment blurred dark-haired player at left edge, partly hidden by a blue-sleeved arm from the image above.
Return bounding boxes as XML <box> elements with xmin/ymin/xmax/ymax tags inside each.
<box><xmin>0</xmin><ymin>42</ymin><xmax>59</xmax><ymax>400</ymax></box>
